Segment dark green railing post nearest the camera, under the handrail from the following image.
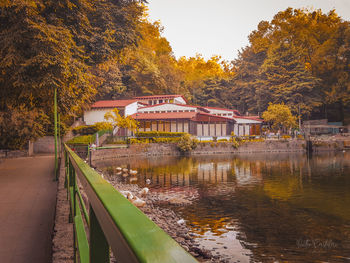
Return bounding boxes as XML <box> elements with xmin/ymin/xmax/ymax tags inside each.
<box><xmin>89</xmin><ymin>205</ymin><xmax>110</xmax><ymax>263</ymax></box>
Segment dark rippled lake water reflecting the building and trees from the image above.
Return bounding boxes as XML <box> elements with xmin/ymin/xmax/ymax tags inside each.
<box><xmin>99</xmin><ymin>152</ymin><xmax>350</xmax><ymax>262</ymax></box>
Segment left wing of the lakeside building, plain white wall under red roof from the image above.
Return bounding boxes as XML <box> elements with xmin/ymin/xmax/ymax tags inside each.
<box><xmin>83</xmin><ymin>99</ymin><xmax>145</xmax><ymax>125</ymax></box>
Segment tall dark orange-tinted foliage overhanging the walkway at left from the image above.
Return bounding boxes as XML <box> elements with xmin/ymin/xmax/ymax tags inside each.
<box><xmin>0</xmin><ymin>0</ymin><xmax>144</xmax><ymax>147</ymax></box>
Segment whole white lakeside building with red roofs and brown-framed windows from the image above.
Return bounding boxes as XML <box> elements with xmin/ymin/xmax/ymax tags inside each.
<box><xmin>84</xmin><ymin>95</ymin><xmax>263</xmax><ymax>138</ymax></box>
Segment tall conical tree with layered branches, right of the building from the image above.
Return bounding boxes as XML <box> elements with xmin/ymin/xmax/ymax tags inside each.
<box><xmin>259</xmin><ymin>44</ymin><xmax>322</xmax><ymax>116</ymax></box>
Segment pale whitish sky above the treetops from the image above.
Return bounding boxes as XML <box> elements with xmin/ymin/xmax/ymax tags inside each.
<box><xmin>148</xmin><ymin>0</ymin><xmax>350</xmax><ymax>61</ymax></box>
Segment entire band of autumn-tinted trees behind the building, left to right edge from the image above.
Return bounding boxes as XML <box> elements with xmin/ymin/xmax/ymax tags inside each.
<box><xmin>0</xmin><ymin>0</ymin><xmax>350</xmax><ymax>151</ymax></box>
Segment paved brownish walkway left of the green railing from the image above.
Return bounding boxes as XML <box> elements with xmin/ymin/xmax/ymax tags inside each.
<box><xmin>0</xmin><ymin>156</ymin><xmax>57</xmax><ymax>263</ymax></box>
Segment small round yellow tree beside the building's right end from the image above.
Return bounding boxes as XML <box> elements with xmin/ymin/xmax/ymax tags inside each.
<box><xmin>262</xmin><ymin>103</ymin><xmax>297</xmax><ymax>131</ymax></box>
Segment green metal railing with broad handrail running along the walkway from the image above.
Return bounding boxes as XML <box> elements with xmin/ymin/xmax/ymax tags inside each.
<box><xmin>64</xmin><ymin>145</ymin><xmax>197</xmax><ymax>263</ymax></box>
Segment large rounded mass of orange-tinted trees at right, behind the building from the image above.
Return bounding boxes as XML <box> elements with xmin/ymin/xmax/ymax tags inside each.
<box><xmin>230</xmin><ymin>8</ymin><xmax>350</xmax><ymax>121</ymax></box>
